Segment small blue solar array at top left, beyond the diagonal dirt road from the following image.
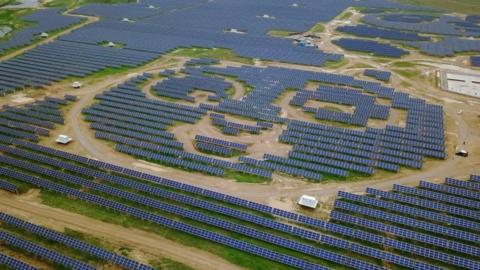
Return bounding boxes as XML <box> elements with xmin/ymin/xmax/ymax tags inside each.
<box><xmin>0</xmin><ymin>8</ymin><xmax>82</xmax><ymax>54</ymax></box>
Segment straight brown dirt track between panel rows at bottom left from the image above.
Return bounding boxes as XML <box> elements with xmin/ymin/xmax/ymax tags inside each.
<box><xmin>0</xmin><ymin>191</ymin><xmax>246</xmax><ymax>270</ymax></box>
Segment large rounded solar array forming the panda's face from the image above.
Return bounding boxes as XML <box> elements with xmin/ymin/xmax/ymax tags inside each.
<box><xmin>84</xmin><ymin>62</ymin><xmax>445</xmax><ymax>181</ymax></box>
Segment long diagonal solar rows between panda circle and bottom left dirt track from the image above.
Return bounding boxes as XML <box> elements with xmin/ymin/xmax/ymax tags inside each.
<box><xmin>0</xmin><ymin>137</ymin><xmax>458</xmax><ymax>269</ymax></box>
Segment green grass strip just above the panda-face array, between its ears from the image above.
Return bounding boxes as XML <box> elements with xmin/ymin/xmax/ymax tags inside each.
<box><xmin>170</xmin><ymin>47</ymin><xmax>254</xmax><ymax>65</ymax></box>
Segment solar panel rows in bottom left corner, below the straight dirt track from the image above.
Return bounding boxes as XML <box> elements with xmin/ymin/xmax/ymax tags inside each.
<box><xmin>0</xmin><ymin>213</ymin><xmax>154</xmax><ymax>270</ymax></box>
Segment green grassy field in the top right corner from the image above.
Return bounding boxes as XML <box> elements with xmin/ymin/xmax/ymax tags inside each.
<box><xmin>396</xmin><ymin>0</ymin><xmax>480</xmax><ymax>14</ymax></box>
